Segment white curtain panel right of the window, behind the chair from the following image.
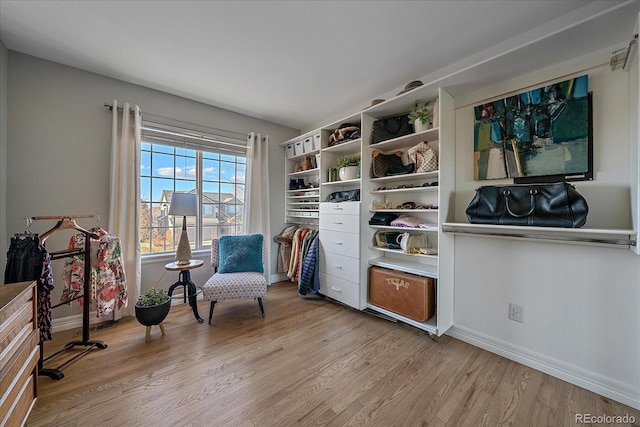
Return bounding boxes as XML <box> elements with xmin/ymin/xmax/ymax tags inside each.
<box><xmin>244</xmin><ymin>132</ymin><xmax>271</xmax><ymax>278</ymax></box>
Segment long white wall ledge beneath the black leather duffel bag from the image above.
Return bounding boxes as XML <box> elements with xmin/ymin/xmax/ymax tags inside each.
<box><xmin>442</xmin><ymin>222</ymin><xmax>638</xmax><ymax>248</ymax></box>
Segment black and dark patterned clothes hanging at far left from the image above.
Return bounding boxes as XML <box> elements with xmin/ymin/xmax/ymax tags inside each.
<box><xmin>4</xmin><ymin>234</ymin><xmax>54</xmax><ymax>341</ymax></box>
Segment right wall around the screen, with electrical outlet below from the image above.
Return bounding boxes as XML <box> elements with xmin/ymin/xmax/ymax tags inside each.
<box><xmin>450</xmin><ymin>57</ymin><xmax>640</xmax><ymax>407</ymax></box>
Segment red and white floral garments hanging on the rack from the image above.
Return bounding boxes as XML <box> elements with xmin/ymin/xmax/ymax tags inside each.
<box><xmin>60</xmin><ymin>227</ymin><xmax>129</xmax><ymax>317</ymax></box>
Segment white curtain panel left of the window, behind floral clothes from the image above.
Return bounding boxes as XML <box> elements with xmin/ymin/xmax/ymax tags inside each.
<box><xmin>107</xmin><ymin>101</ymin><xmax>142</xmax><ymax>320</ymax></box>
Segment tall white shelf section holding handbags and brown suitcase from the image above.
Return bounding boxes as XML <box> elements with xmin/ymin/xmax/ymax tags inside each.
<box><xmin>361</xmin><ymin>85</ymin><xmax>455</xmax><ymax>335</ymax></box>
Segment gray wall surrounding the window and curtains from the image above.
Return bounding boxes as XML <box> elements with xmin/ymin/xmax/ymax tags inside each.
<box><xmin>5</xmin><ymin>51</ymin><xmax>299</xmax><ymax>319</ymax></box>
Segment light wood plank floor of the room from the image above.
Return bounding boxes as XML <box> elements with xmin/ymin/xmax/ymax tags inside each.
<box><xmin>28</xmin><ymin>282</ymin><xmax>640</xmax><ymax>427</ymax></box>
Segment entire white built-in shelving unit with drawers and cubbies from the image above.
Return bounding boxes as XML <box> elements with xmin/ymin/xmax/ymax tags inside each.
<box><xmin>281</xmin><ymin>85</ymin><xmax>455</xmax><ymax>335</ymax></box>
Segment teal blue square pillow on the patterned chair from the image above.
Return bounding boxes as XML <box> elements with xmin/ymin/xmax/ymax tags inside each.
<box><xmin>218</xmin><ymin>233</ymin><xmax>264</xmax><ymax>274</ymax></box>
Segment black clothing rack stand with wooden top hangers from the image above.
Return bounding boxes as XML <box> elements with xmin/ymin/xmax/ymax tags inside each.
<box><xmin>33</xmin><ymin>215</ymin><xmax>107</xmax><ymax>380</ymax></box>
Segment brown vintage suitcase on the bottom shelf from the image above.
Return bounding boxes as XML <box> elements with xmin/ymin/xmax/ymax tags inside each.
<box><xmin>369</xmin><ymin>266</ymin><xmax>436</xmax><ymax>322</ymax></box>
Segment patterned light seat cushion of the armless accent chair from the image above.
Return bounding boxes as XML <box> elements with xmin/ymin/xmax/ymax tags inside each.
<box><xmin>202</xmin><ymin>272</ymin><xmax>267</xmax><ymax>301</ymax></box>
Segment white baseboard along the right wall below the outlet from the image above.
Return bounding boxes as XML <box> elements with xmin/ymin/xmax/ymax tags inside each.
<box><xmin>446</xmin><ymin>326</ymin><xmax>640</xmax><ymax>409</ymax></box>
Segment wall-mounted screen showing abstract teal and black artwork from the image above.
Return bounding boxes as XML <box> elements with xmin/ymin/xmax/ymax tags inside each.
<box><xmin>474</xmin><ymin>74</ymin><xmax>593</xmax><ymax>183</ymax></box>
